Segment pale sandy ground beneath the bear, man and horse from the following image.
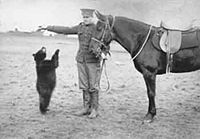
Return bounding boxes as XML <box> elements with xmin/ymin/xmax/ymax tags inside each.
<box><xmin>0</xmin><ymin>35</ymin><xmax>200</xmax><ymax>139</ymax></box>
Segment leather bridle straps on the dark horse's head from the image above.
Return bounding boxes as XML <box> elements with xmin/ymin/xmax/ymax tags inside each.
<box><xmin>91</xmin><ymin>15</ymin><xmax>115</xmax><ymax>47</ymax></box>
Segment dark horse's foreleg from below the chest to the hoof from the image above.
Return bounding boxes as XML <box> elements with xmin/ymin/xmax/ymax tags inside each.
<box><xmin>143</xmin><ymin>73</ymin><xmax>156</xmax><ymax>122</ymax></box>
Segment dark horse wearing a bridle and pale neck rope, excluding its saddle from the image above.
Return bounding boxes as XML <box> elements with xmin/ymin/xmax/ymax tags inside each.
<box><xmin>90</xmin><ymin>11</ymin><xmax>200</xmax><ymax>123</ymax></box>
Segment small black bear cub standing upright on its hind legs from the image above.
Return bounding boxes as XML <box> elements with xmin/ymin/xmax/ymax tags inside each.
<box><xmin>33</xmin><ymin>47</ymin><xmax>59</xmax><ymax>114</ymax></box>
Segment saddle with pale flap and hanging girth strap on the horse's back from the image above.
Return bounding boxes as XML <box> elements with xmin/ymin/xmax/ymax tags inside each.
<box><xmin>152</xmin><ymin>21</ymin><xmax>200</xmax><ymax>73</ymax></box>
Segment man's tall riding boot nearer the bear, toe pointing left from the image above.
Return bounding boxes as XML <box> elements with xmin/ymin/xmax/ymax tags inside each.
<box><xmin>76</xmin><ymin>90</ymin><xmax>91</xmax><ymax>116</ymax></box>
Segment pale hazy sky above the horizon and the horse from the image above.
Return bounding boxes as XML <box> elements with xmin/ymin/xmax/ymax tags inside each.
<box><xmin>0</xmin><ymin>0</ymin><xmax>200</xmax><ymax>31</ymax></box>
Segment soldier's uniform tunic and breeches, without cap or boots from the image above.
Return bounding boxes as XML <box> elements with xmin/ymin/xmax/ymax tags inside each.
<box><xmin>47</xmin><ymin>23</ymin><xmax>101</xmax><ymax>92</ymax></box>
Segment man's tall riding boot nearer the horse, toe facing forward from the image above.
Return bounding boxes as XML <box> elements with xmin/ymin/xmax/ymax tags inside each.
<box><xmin>88</xmin><ymin>91</ymin><xmax>99</xmax><ymax>119</ymax></box>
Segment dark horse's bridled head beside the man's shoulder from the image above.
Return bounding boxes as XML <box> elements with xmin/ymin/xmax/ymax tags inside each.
<box><xmin>90</xmin><ymin>11</ymin><xmax>114</xmax><ymax>54</ymax></box>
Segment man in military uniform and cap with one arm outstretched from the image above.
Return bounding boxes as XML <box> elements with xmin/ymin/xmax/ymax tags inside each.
<box><xmin>39</xmin><ymin>9</ymin><xmax>102</xmax><ymax>118</ymax></box>
